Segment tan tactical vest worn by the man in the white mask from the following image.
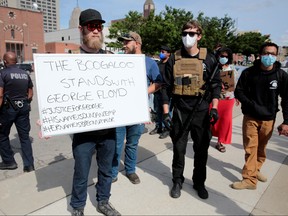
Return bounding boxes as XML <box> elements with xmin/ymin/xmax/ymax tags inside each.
<box><xmin>173</xmin><ymin>48</ymin><xmax>207</xmax><ymax>96</ymax></box>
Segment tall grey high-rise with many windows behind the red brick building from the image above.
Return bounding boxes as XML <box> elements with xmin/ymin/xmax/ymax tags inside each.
<box><xmin>0</xmin><ymin>0</ymin><xmax>60</xmax><ymax>32</ymax></box>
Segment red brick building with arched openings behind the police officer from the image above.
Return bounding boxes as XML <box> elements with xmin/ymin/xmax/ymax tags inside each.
<box><xmin>0</xmin><ymin>5</ymin><xmax>45</xmax><ymax>62</ymax></box>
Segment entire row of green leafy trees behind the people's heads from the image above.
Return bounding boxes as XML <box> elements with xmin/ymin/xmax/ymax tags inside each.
<box><xmin>108</xmin><ymin>6</ymin><xmax>269</xmax><ymax>56</ymax></box>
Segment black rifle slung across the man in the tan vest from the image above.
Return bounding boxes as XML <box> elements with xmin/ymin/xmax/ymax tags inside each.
<box><xmin>176</xmin><ymin>64</ymin><xmax>219</xmax><ymax>142</ymax></box>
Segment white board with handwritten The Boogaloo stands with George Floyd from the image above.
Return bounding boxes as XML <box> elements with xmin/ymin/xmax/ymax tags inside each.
<box><xmin>34</xmin><ymin>54</ymin><xmax>150</xmax><ymax>136</ymax></box>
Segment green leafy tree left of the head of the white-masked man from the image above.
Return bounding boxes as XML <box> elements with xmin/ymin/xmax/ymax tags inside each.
<box><xmin>108</xmin><ymin>6</ymin><xmax>193</xmax><ymax>54</ymax></box>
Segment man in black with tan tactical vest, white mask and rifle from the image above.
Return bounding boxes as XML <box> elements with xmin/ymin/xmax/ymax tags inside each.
<box><xmin>162</xmin><ymin>20</ymin><xmax>221</xmax><ymax>199</ymax></box>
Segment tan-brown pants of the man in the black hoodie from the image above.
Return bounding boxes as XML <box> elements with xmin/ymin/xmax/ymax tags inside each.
<box><xmin>242</xmin><ymin>115</ymin><xmax>275</xmax><ymax>185</ymax></box>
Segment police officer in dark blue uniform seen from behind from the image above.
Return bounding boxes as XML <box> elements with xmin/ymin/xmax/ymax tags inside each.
<box><xmin>0</xmin><ymin>52</ymin><xmax>34</xmax><ymax>172</ymax></box>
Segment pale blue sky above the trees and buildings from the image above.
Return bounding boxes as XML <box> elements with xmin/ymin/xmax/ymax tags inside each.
<box><xmin>60</xmin><ymin>0</ymin><xmax>288</xmax><ymax>46</ymax></box>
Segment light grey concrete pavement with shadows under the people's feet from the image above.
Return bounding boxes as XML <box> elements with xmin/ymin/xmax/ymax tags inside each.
<box><xmin>0</xmin><ymin>73</ymin><xmax>288</xmax><ymax>215</ymax></box>
